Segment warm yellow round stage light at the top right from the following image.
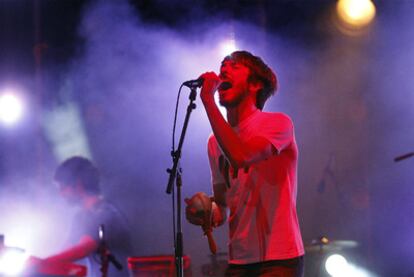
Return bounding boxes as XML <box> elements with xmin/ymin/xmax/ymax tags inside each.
<box><xmin>336</xmin><ymin>0</ymin><xmax>375</xmax><ymax>28</ymax></box>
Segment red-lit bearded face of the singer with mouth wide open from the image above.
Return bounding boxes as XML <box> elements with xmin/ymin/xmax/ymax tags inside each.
<box><xmin>218</xmin><ymin>60</ymin><xmax>250</xmax><ymax>107</ymax></box>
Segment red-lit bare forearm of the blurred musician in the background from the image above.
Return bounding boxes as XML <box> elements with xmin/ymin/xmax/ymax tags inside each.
<box><xmin>46</xmin><ymin>235</ymin><xmax>98</xmax><ymax>262</ymax></box>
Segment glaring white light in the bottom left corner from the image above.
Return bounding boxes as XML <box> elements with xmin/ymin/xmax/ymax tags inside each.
<box><xmin>0</xmin><ymin>247</ymin><xmax>29</xmax><ymax>276</ymax></box>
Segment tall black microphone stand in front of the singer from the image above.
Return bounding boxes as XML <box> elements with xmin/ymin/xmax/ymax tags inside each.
<box><xmin>166</xmin><ymin>86</ymin><xmax>197</xmax><ymax>277</ymax></box>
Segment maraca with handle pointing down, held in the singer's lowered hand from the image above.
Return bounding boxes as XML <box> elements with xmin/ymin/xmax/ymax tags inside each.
<box><xmin>184</xmin><ymin>192</ymin><xmax>217</xmax><ymax>254</ymax></box>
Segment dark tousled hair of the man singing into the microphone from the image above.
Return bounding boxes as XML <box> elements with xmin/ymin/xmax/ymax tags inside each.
<box><xmin>223</xmin><ymin>51</ymin><xmax>278</xmax><ymax>110</ymax></box>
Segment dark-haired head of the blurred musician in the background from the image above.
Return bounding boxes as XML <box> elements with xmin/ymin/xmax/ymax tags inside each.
<box><xmin>54</xmin><ymin>156</ymin><xmax>101</xmax><ymax>202</ymax></box>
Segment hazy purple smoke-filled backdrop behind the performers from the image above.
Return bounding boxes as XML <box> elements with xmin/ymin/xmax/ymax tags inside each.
<box><xmin>0</xmin><ymin>0</ymin><xmax>414</xmax><ymax>276</ymax></box>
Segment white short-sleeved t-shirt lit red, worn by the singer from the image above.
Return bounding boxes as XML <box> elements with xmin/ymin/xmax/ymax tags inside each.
<box><xmin>208</xmin><ymin>110</ymin><xmax>304</xmax><ymax>264</ymax></box>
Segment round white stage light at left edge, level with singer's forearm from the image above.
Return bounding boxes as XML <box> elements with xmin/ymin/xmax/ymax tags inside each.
<box><xmin>0</xmin><ymin>92</ymin><xmax>23</xmax><ymax>125</ymax></box>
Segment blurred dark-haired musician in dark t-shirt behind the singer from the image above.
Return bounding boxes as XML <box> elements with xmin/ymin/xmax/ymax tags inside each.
<box><xmin>45</xmin><ymin>156</ymin><xmax>133</xmax><ymax>277</ymax></box>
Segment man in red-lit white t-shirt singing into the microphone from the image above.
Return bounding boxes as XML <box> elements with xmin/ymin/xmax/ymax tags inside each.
<box><xmin>187</xmin><ymin>51</ymin><xmax>304</xmax><ymax>277</ymax></box>
